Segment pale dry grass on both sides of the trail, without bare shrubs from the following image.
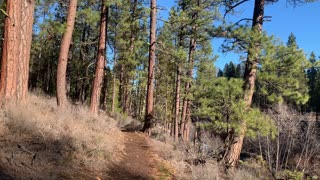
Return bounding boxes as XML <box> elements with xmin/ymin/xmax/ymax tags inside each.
<box><xmin>0</xmin><ymin>94</ymin><xmax>270</xmax><ymax>180</ymax></box>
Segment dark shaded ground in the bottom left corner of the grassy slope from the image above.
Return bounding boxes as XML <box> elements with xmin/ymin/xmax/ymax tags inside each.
<box><xmin>0</xmin><ymin>131</ymin><xmax>99</xmax><ymax>180</ymax></box>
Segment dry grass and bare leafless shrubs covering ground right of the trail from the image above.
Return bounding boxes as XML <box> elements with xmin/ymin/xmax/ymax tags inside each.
<box><xmin>147</xmin><ymin>105</ymin><xmax>320</xmax><ymax>180</ymax></box>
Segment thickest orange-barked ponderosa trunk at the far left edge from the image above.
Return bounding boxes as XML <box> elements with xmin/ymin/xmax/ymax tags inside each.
<box><xmin>0</xmin><ymin>0</ymin><xmax>35</xmax><ymax>103</ymax></box>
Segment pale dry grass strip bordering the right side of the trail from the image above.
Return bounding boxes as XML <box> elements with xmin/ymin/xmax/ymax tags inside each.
<box><xmin>150</xmin><ymin>134</ymin><xmax>268</xmax><ymax>180</ymax></box>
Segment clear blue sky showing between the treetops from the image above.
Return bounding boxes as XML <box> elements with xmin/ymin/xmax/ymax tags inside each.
<box><xmin>158</xmin><ymin>0</ymin><xmax>320</xmax><ymax>68</ymax></box>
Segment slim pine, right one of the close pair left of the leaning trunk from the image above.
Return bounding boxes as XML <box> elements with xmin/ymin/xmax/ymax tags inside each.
<box><xmin>180</xmin><ymin>0</ymin><xmax>218</xmax><ymax>141</ymax></box>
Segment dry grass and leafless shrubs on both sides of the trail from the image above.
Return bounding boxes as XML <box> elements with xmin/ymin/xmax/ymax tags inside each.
<box><xmin>0</xmin><ymin>94</ymin><xmax>320</xmax><ymax>180</ymax></box>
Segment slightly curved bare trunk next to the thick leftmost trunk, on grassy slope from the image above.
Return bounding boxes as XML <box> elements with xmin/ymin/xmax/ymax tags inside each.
<box><xmin>57</xmin><ymin>0</ymin><xmax>77</xmax><ymax>106</ymax></box>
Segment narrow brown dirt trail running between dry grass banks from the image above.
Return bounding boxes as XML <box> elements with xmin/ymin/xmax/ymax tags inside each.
<box><xmin>107</xmin><ymin>132</ymin><xmax>175</xmax><ymax>180</ymax></box>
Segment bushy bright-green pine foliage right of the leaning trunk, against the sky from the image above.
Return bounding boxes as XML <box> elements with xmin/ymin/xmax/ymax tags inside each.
<box><xmin>258</xmin><ymin>35</ymin><xmax>309</xmax><ymax>105</ymax></box>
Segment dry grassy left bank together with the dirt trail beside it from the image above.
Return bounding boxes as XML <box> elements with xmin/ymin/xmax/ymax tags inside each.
<box><xmin>0</xmin><ymin>95</ymin><xmax>176</xmax><ymax>180</ymax></box>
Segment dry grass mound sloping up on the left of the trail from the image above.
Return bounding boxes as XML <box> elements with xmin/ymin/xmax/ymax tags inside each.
<box><xmin>0</xmin><ymin>94</ymin><xmax>123</xmax><ymax>179</ymax></box>
